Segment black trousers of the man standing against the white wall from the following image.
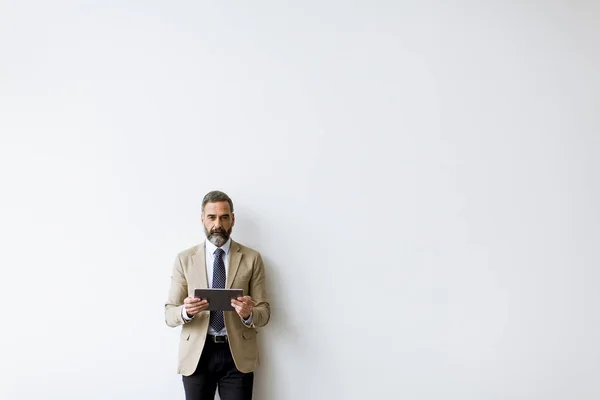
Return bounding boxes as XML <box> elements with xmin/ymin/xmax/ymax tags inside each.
<box><xmin>183</xmin><ymin>337</ymin><xmax>254</xmax><ymax>400</ymax></box>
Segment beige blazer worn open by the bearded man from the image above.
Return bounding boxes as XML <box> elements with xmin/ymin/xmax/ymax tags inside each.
<box><xmin>165</xmin><ymin>240</ymin><xmax>271</xmax><ymax>376</ymax></box>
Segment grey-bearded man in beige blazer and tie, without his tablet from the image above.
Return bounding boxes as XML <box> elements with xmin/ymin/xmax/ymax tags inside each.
<box><xmin>165</xmin><ymin>191</ymin><xmax>271</xmax><ymax>400</ymax></box>
